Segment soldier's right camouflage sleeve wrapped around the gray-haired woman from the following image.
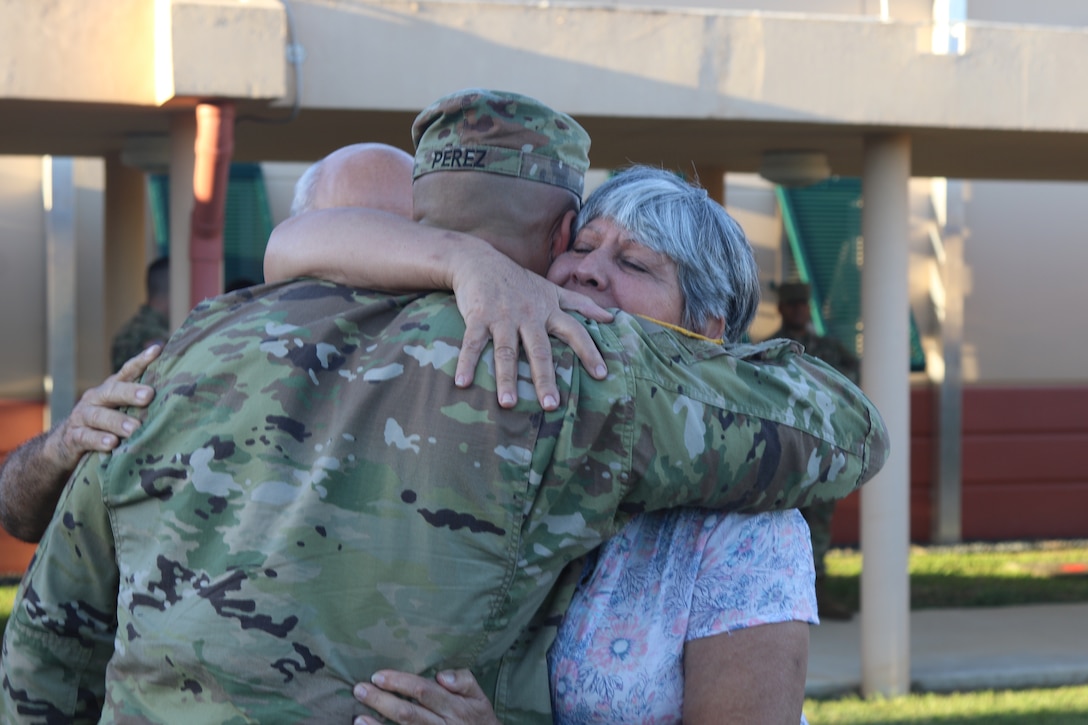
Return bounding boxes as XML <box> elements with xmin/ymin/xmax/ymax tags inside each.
<box><xmin>596</xmin><ymin>320</ymin><xmax>888</xmax><ymax>514</ymax></box>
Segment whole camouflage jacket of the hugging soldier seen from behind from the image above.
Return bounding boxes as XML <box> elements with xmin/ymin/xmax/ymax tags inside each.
<box><xmin>0</xmin><ymin>280</ymin><xmax>888</xmax><ymax>723</ymax></box>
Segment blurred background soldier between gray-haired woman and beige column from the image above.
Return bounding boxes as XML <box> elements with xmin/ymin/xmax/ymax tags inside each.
<box><xmin>771</xmin><ymin>282</ymin><xmax>861</xmax><ymax>619</ymax></box>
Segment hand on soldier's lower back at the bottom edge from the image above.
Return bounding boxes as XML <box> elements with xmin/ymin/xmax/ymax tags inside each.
<box><xmin>354</xmin><ymin>669</ymin><xmax>499</xmax><ymax>725</ymax></box>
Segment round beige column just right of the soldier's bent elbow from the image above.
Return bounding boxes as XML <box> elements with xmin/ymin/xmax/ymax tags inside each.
<box><xmin>861</xmin><ymin>134</ymin><xmax>911</xmax><ymax>696</ymax></box>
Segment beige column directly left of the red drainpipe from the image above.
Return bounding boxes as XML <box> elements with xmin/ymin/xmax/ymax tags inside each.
<box><xmin>170</xmin><ymin>110</ymin><xmax>197</xmax><ymax>330</ymax></box>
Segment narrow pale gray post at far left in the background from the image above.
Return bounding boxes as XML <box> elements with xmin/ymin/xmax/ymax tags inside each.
<box><xmin>41</xmin><ymin>156</ymin><xmax>76</xmax><ymax>428</ymax></box>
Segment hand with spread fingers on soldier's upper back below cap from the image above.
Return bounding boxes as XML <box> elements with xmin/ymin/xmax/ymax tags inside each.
<box><xmin>452</xmin><ymin>250</ymin><xmax>613</xmax><ymax>410</ymax></box>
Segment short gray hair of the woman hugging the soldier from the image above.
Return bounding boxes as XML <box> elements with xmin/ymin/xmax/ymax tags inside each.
<box><xmin>573</xmin><ymin>165</ymin><xmax>759</xmax><ymax>342</ymax></box>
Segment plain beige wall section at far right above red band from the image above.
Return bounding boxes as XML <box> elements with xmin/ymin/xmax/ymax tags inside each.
<box><xmin>964</xmin><ymin>181</ymin><xmax>1088</xmax><ymax>384</ymax></box>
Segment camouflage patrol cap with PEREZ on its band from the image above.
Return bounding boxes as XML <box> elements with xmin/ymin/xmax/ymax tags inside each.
<box><xmin>411</xmin><ymin>88</ymin><xmax>590</xmax><ymax>198</ymax></box>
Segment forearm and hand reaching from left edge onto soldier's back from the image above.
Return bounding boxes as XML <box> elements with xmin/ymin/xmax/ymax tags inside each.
<box><xmin>0</xmin><ymin>345</ymin><xmax>162</xmax><ymax>543</ymax></box>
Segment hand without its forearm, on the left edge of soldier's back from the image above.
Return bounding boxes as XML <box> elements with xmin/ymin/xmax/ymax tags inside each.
<box><xmin>54</xmin><ymin>345</ymin><xmax>162</xmax><ymax>469</ymax></box>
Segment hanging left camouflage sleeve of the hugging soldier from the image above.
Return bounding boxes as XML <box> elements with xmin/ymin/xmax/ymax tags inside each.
<box><xmin>0</xmin><ymin>454</ymin><xmax>118</xmax><ymax>723</ymax></box>
